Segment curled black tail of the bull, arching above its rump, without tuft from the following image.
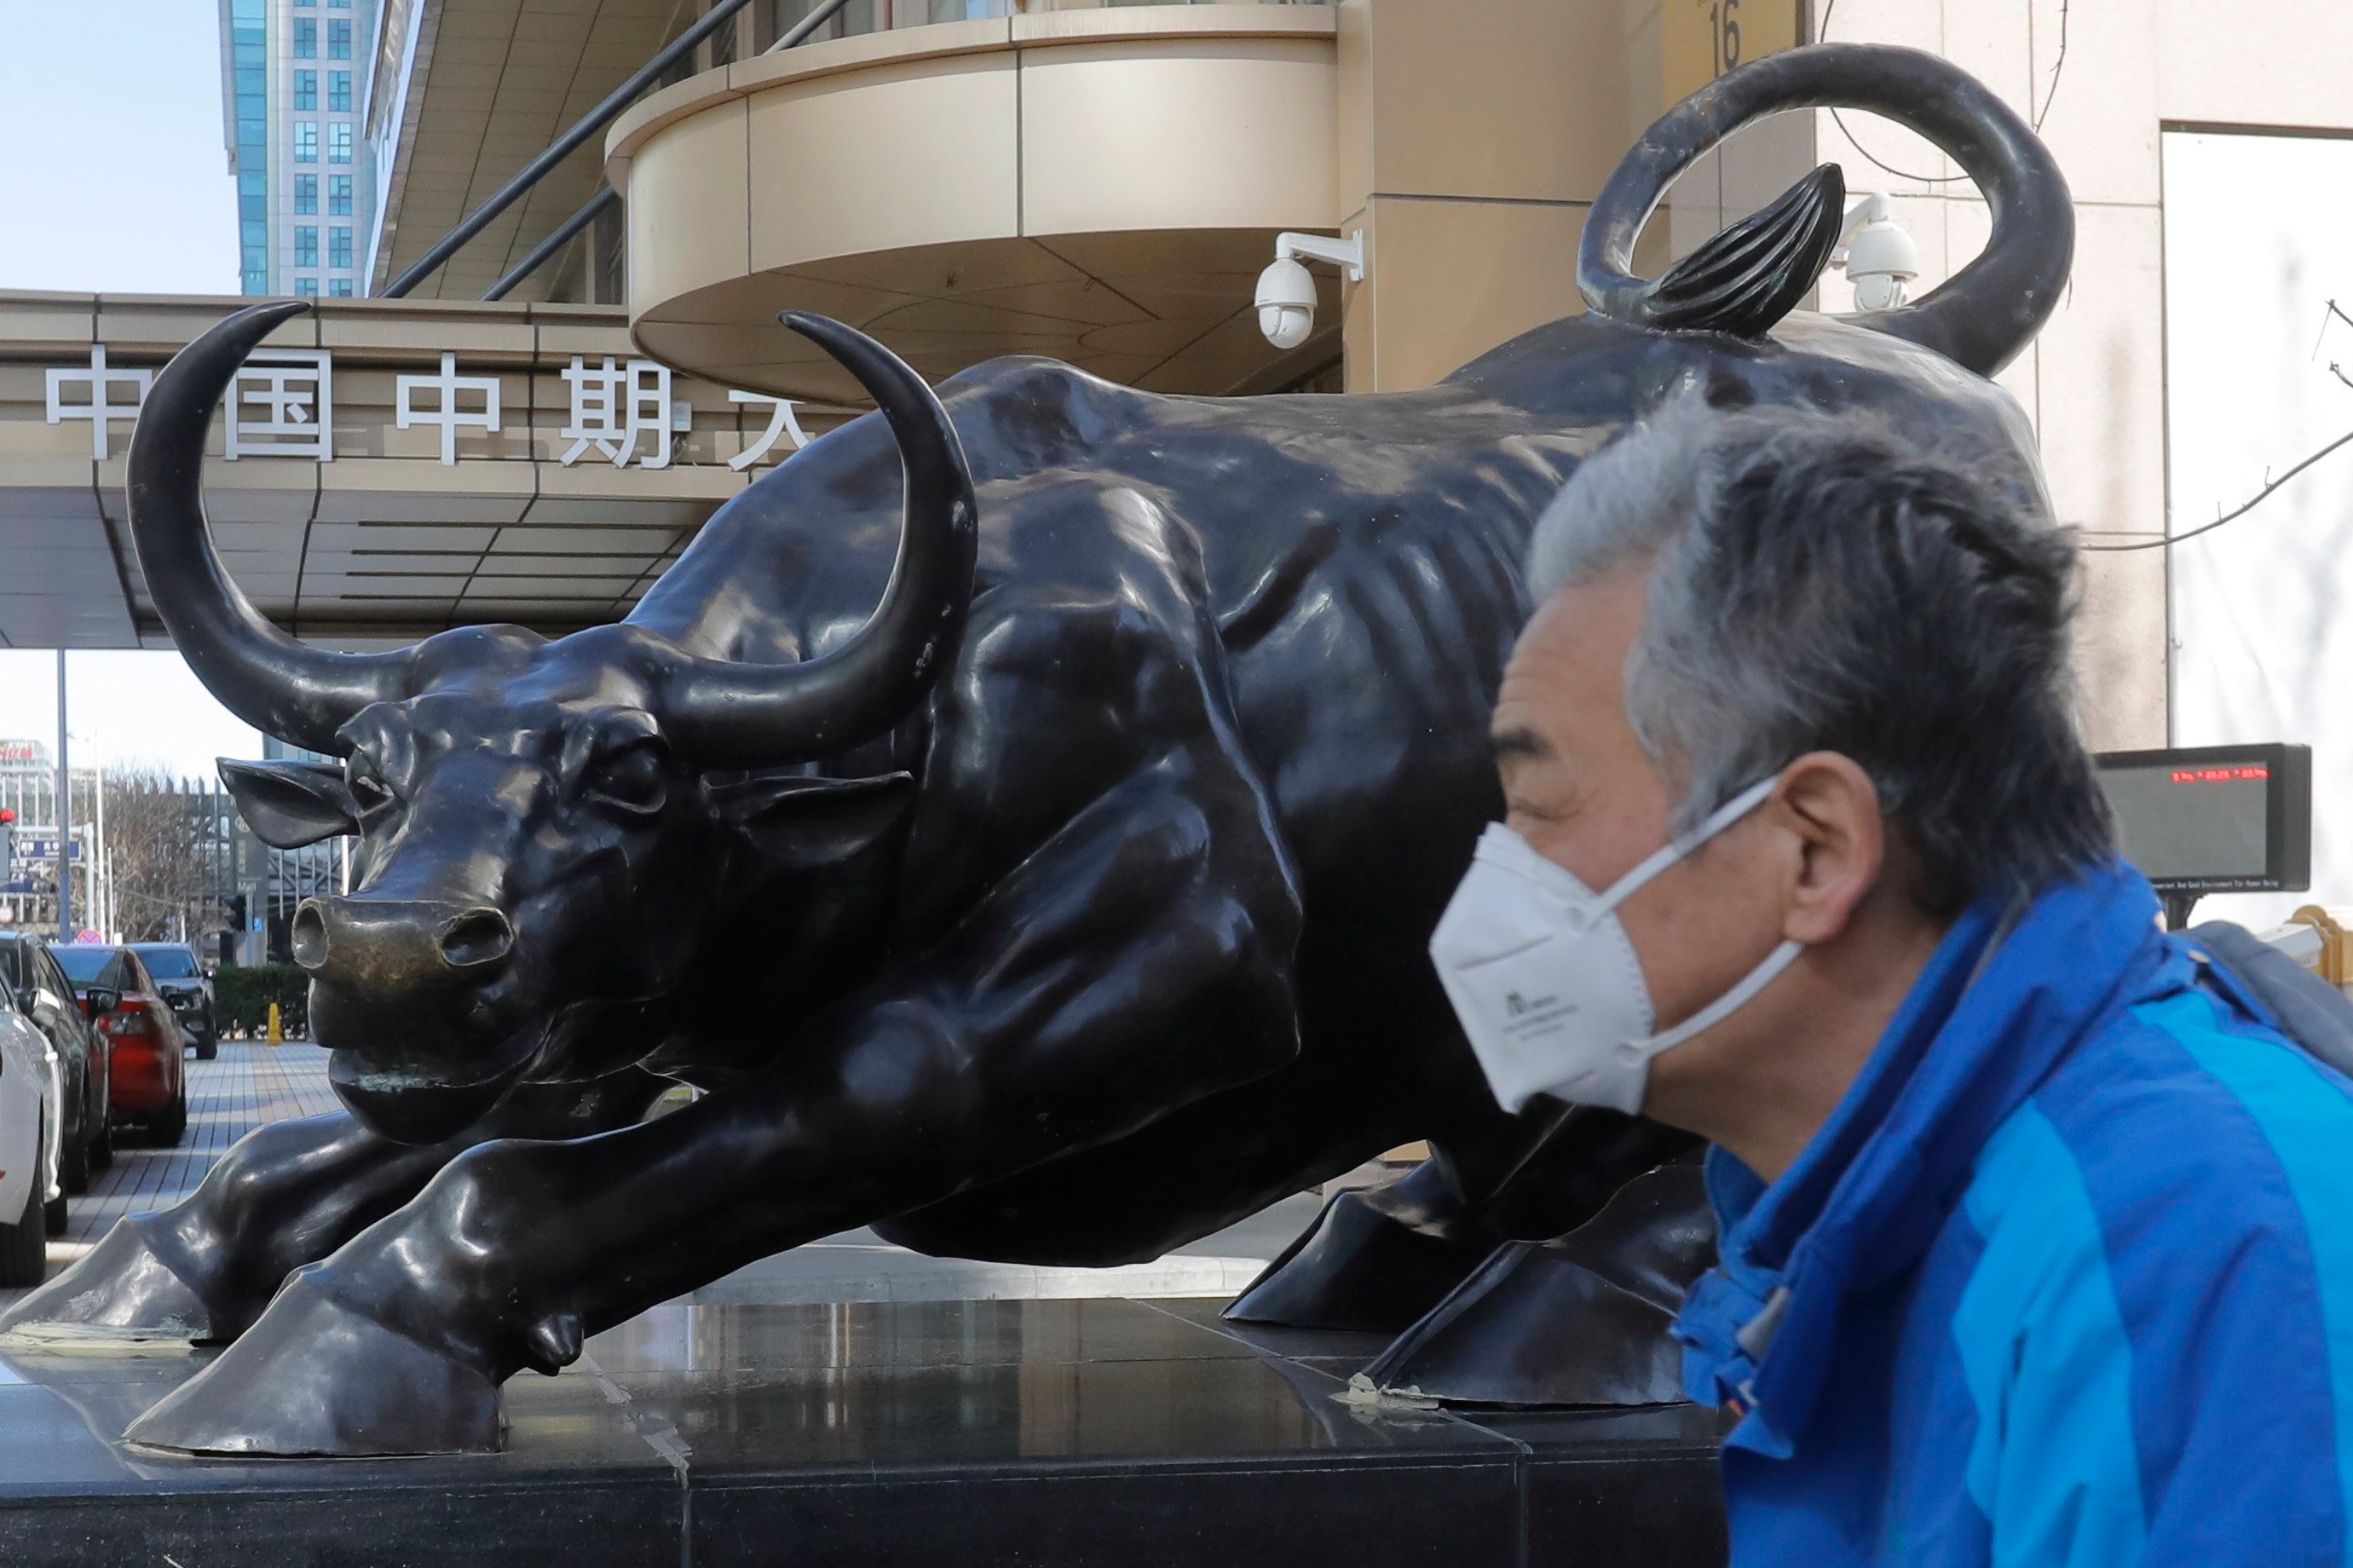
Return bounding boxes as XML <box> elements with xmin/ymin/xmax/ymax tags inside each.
<box><xmin>1577</xmin><ymin>44</ymin><xmax>2075</xmax><ymax>377</ymax></box>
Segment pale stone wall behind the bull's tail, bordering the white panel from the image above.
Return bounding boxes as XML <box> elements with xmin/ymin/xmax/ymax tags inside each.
<box><xmin>1814</xmin><ymin>0</ymin><xmax>2353</xmax><ymax>747</ymax></box>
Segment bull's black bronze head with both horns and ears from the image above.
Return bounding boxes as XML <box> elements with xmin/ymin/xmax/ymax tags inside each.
<box><xmin>130</xmin><ymin>303</ymin><xmax>977</xmax><ymax>1142</ymax></box>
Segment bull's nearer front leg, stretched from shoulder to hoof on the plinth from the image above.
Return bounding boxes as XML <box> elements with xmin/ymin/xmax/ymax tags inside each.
<box><xmin>130</xmin><ymin>775</ymin><xmax>1299</xmax><ymax>1453</ymax></box>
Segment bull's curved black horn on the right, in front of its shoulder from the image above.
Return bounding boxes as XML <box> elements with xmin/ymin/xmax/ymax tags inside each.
<box><xmin>666</xmin><ymin>311</ymin><xmax>979</xmax><ymax>768</ymax></box>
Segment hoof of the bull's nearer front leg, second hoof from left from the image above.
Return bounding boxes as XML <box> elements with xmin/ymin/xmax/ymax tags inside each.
<box><xmin>123</xmin><ymin>1269</ymin><xmax>501</xmax><ymax>1457</ymax></box>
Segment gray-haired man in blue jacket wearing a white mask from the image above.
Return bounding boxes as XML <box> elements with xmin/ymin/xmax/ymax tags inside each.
<box><xmin>1431</xmin><ymin>398</ymin><xmax>2353</xmax><ymax>1568</ymax></box>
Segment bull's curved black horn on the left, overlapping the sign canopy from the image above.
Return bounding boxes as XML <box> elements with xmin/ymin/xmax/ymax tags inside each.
<box><xmin>130</xmin><ymin>302</ymin><xmax>412</xmax><ymax>751</ymax></box>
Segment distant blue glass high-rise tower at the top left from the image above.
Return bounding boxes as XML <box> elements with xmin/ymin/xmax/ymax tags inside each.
<box><xmin>222</xmin><ymin>0</ymin><xmax>379</xmax><ymax>297</ymax></box>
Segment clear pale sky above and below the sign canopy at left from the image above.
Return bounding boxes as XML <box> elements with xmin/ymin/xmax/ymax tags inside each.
<box><xmin>0</xmin><ymin>0</ymin><xmax>261</xmax><ymax>777</ymax></box>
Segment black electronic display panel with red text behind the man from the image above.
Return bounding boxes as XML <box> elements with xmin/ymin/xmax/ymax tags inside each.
<box><xmin>2096</xmin><ymin>744</ymin><xmax>2313</xmax><ymax>892</ymax></box>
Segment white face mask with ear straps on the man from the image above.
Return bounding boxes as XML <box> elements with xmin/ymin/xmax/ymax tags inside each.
<box><xmin>1431</xmin><ymin>779</ymin><xmax>1805</xmax><ymax>1116</ymax></box>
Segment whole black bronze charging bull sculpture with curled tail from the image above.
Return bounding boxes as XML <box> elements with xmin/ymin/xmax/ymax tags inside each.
<box><xmin>7</xmin><ymin>44</ymin><xmax>2073</xmax><ymax>1453</ymax></box>
